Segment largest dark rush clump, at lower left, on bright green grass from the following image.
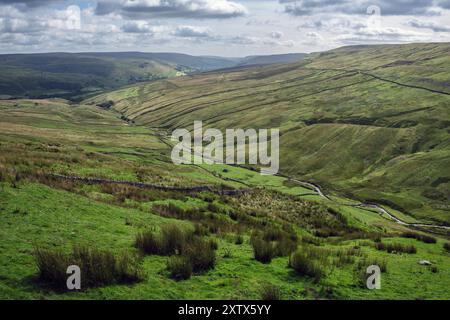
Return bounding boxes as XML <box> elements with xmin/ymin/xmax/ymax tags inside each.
<box><xmin>34</xmin><ymin>247</ymin><xmax>144</xmax><ymax>289</ymax></box>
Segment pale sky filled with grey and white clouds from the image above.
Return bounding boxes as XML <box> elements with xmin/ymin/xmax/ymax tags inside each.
<box><xmin>0</xmin><ymin>0</ymin><xmax>450</xmax><ymax>56</ymax></box>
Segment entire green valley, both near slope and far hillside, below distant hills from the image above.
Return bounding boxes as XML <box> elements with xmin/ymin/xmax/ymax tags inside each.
<box><xmin>0</xmin><ymin>43</ymin><xmax>450</xmax><ymax>300</ymax></box>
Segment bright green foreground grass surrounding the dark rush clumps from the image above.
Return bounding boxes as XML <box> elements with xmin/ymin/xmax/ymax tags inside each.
<box><xmin>0</xmin><ymin>184</ymin><xmax>450</xmax><ymax>299</ymax></box>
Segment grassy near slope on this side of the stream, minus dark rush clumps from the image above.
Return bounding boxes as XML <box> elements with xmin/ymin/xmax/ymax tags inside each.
<box><xmin>0</xmin><ymin>97</ymin><xmax>450</xmax><ymax>300</ymax></box>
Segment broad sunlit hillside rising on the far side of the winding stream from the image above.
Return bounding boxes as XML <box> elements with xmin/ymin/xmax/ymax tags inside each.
<box><xmin>86</xmin><ymin>43</ymin><xmax>450</xmax><ymax>223</ymax></box>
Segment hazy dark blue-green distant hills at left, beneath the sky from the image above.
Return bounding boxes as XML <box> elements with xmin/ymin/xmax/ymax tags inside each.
<box><xmin>0</xmin><ymin>52</ymin><xmax>308</xmax><ymax>100</ymax></box>
